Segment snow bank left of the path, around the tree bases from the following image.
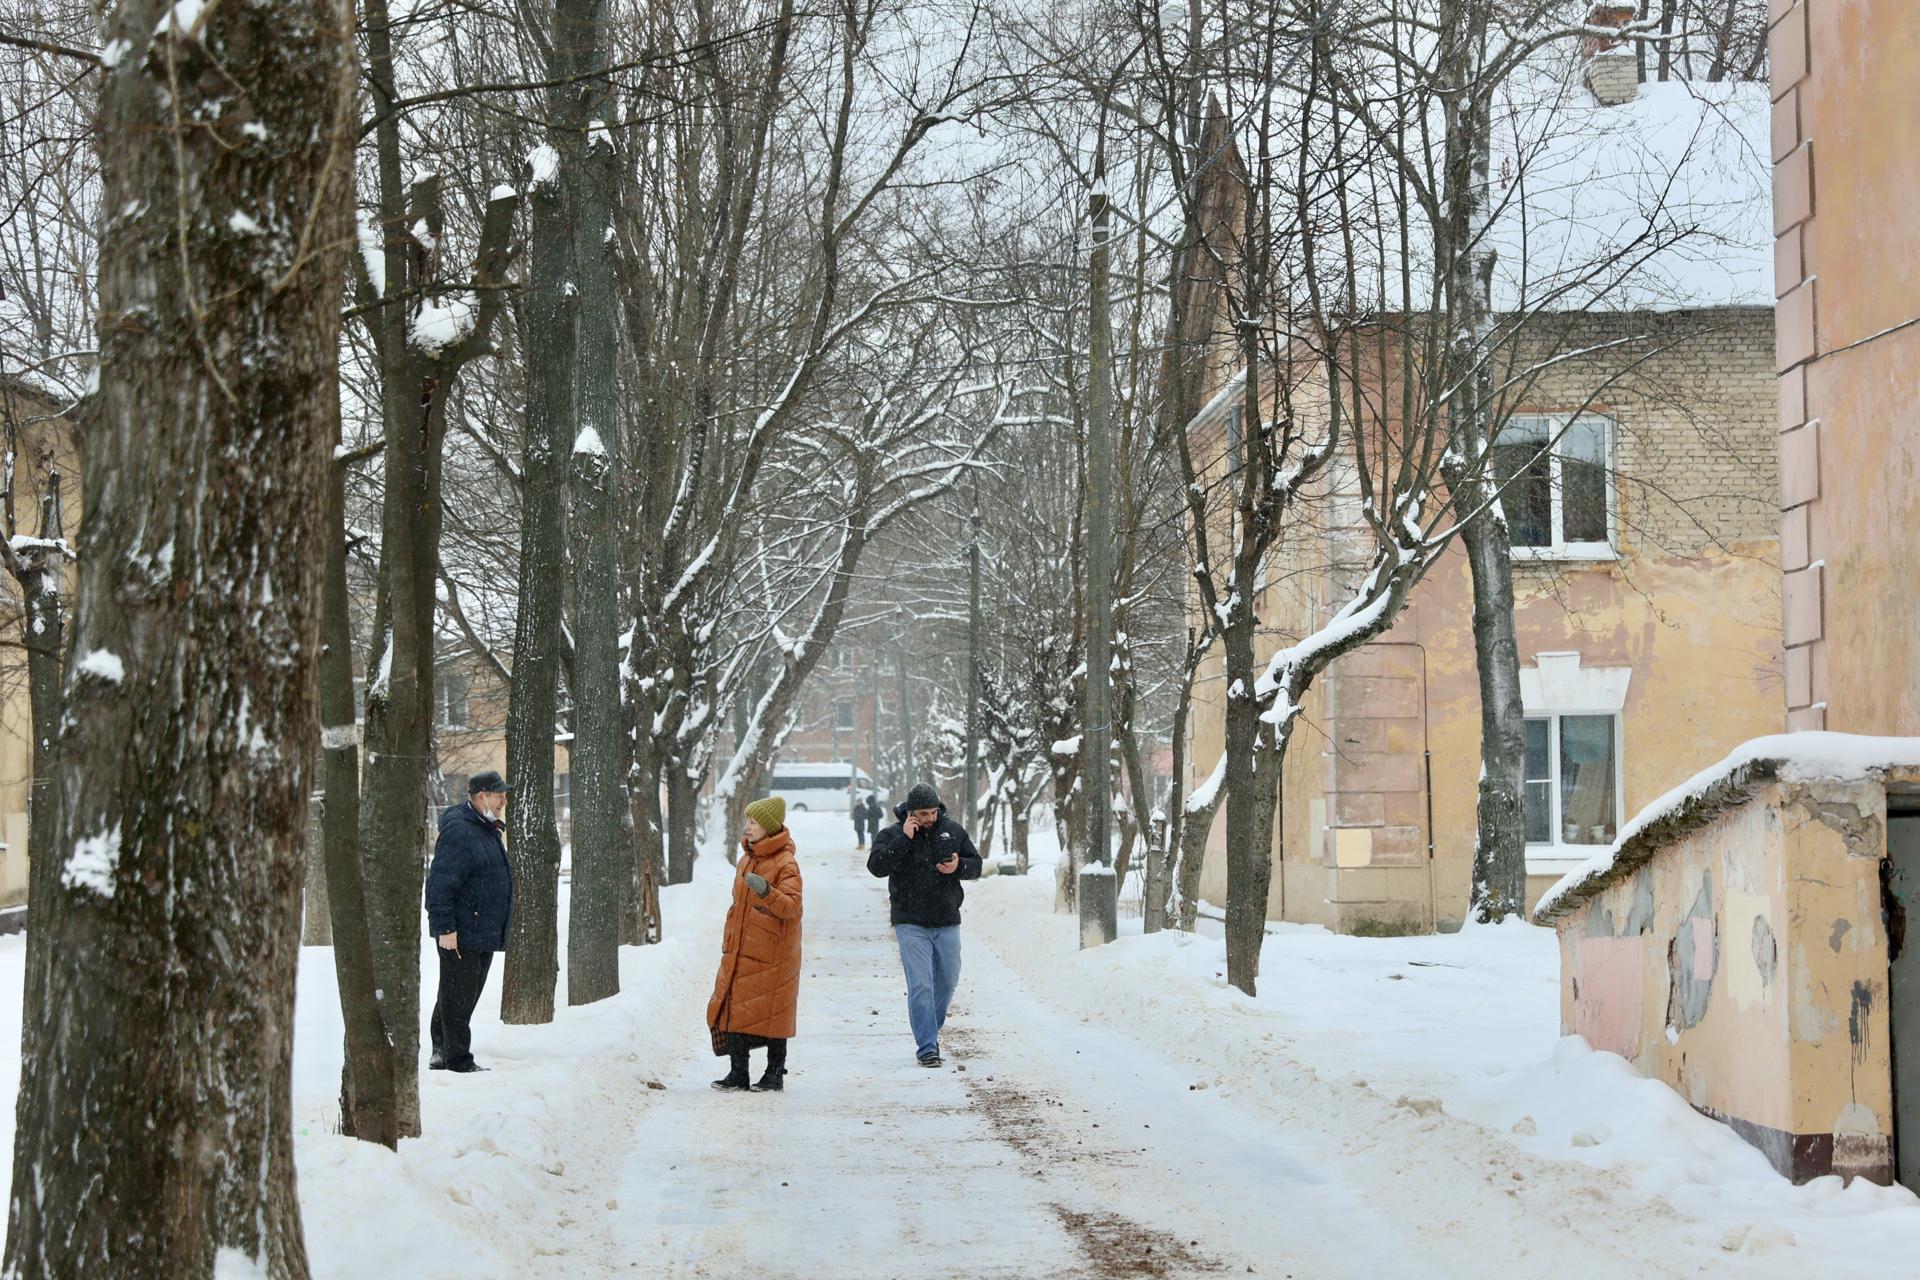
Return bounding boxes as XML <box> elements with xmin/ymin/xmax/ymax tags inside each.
<box><xmin>294</xmin><ymin>856</ymin><xmax>732</xmax><ymax>1280</ymax></box>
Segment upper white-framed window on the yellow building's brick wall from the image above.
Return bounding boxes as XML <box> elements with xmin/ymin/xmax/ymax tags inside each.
<box><xmin>1494</xmin><ymin>416</ymin><xmax>1615</xmax><ymax>558</ymax></box>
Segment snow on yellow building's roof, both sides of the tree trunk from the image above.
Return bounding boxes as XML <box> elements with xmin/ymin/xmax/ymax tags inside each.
<box><xmin>1215</xmin><ymin>44</ymin><xmax>1774</xmax><ymax>315</ymax></box>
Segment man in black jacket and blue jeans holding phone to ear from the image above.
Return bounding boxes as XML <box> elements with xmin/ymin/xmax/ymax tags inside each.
<box><xmin>866</xmin><ymin>783</ymin><xmax>979</xmax><ymax>1067</ymax></box>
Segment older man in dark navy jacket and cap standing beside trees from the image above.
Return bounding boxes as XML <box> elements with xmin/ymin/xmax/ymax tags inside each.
<box><xmin>426</xmin><ymin>770</ymin><xmax>513</xmax><ymax>1071</ymax></box>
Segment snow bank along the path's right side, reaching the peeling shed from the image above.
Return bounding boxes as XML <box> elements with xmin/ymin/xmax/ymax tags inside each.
<box><xmin>968</xmin><ymin>871</ymin><xmax>1920</xmax><ymax>1276</ymax></box>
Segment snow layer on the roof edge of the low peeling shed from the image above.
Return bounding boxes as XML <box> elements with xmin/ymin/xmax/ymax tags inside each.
<box><xmin>1534</xmin><ymin>733</ymin><xmax>1920</xmax><ymax>925</ymax></box>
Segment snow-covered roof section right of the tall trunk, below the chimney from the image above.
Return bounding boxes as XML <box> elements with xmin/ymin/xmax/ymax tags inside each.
<box><xmin>1488</xmin><ymin>69</ymin><xmax>1774</xmax><ymax>311</ymax></box>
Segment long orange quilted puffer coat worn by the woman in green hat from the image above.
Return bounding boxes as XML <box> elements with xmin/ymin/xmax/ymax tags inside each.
<box><xmin>707</xmin><ymin>827</ymin><xmax>801</xmax><ymax>1052</ymax></box>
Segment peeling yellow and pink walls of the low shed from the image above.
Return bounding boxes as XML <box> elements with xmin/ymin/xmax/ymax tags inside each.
<box><xmin>1557</xmin><ymin>783</ymin><xmax>1893</xmax><ymax>1182</ymax></box>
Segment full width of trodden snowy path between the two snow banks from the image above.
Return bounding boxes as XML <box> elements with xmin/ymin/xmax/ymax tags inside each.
<box><xmin>595</xmin><ymin>825</ymin><xmax>1745</xmax><ymax>1280</ymax></box>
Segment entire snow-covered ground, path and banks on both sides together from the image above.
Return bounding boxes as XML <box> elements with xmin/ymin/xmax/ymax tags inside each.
<box><xmin>0</xmin><ymin>816</ymin><xmax>1920</xmax><ymax>1280</ymax></box>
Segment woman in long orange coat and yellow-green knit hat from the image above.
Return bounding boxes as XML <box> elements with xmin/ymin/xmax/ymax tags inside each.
<box><xmin>707</xmin><ymin>796</ymin><xmax>801</xmax><ymax>1092</ymax></box>
